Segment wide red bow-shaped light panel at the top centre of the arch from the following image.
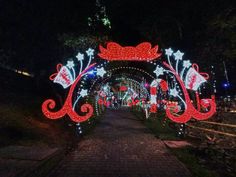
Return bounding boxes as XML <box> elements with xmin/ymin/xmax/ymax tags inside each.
<box><xmin>98</xmin><ymin>42</ymin><xmax>161</xmax><ymax>61</ymax></box>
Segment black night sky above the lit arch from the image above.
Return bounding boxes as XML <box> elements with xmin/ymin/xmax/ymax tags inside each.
<box><xmin>0</xmin><ymin>0</ymin><xmax>236</xmax><ymax>95</ymax></box>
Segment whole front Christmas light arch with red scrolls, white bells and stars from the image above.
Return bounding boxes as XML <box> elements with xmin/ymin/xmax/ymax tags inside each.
<box><xmin>42</xmin><ymin>42</ymin><xmax>216</xmax><ymax>123</ymax></box>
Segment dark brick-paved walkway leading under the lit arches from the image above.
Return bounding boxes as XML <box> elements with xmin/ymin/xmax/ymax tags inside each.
<box><xmin>49</xmin><ymin>110</ymin><xmax>191</xmax><ymax>177</ymax></box>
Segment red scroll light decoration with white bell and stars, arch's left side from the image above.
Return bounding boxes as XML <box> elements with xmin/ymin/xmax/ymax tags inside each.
<box><xmin>42</xmin><ymin>48</ymin><xmax>106</xmax><ymax>122</ymax></box>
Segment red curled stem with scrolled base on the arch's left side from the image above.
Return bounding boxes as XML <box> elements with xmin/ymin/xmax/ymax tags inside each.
<box><xmin>42</xmin><ymin>63</ymin><xmax>96</xmax><ymax>122</ymax></box>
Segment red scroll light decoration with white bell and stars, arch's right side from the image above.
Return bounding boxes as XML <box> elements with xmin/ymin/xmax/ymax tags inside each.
<box><xmin>154</xmin><ymin>48</ymin><xmax>216</xmax><ymax>123</ymax></box>
